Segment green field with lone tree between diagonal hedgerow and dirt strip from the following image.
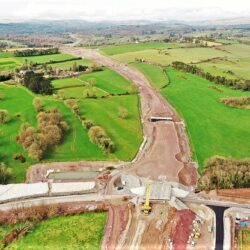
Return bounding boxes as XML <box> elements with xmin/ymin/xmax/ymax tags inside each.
<box><xmin>80</xmin><ymin>95</ymin><xmax>142</xmax><ymax>161</ymax></box>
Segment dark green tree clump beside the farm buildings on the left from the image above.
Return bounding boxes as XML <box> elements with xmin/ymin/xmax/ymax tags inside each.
<box><xmin>23</xmin><ymin>71</ymin><xmax>53</xmax><ymax>95</ymax></box>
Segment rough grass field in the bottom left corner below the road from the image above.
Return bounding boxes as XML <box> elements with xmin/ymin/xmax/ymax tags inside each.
<box><xmin>6</xmin><ymin>213</ymin><xmax>106</xmax><ymax>250</ymax></box>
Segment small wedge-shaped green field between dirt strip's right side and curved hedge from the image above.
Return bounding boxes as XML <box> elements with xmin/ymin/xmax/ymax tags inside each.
<box><xmin>132</xmin><ymin>63</ymin><xmax>169</xmax><ymax>90</ymax></box>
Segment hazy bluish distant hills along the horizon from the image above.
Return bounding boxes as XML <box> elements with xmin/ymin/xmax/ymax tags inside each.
<box><xmin>0</xmin><ymin>17</ymin><xmax>250</xmax><ymax>35</ymax></box>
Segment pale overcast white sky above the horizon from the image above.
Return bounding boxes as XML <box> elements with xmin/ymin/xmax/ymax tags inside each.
<box><xmin>0</xmin><ymin>0</ymin><xmax>250</xmax><ymax>21</ymax></box>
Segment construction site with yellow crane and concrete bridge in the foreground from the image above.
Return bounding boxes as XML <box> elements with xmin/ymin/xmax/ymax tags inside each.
<box><xmin>102</xmin><ymin>177</ymin><xmax>216</xmax><ymax>250</ymax></box>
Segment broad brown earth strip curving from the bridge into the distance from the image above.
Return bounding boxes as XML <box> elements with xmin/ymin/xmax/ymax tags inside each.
<box><xmin>61</xmin><ymin>47</ymin><xmax>197</xmax><ymax>189</ymax></box>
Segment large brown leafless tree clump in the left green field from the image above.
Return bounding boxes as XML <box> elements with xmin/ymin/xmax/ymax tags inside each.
<box><xmin>16</xmin><ymin>109</ymin><xmax>68</xmax><ymax>160</ymax></box>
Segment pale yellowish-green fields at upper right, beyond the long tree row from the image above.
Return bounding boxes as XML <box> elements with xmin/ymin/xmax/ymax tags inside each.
<box><xmin>104</xmin><ymin>40</ymin><xmax>250</xmax><ymax>83</ymax></box>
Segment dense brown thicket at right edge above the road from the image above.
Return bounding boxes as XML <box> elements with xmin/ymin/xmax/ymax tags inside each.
<box><xmin>198</xmin><ymin>156</ymin><xmax>250</xmax><ymax>191</ymax></box>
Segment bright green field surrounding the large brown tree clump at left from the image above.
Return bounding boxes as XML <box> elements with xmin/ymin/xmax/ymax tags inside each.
<box><xmin>0</xmin><ymin>84</ymin><xmax>108</xmax><ymax>182</ymax></box>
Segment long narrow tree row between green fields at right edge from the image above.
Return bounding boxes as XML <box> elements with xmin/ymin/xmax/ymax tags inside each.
<box><xmin>172</xmin><ymin>61</ymin><xmax>250</xmax><ymax>91</ymax></box>
